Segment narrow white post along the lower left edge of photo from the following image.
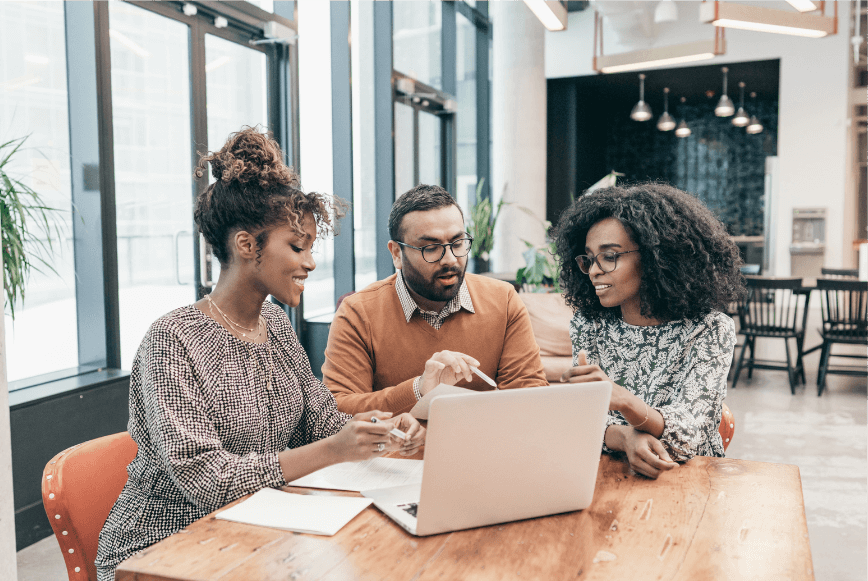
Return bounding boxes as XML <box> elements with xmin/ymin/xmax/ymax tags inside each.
<box><xmin>0</xmin><ymin>253</ymin><xmax>18</xmax><ymax>581</ymax></box>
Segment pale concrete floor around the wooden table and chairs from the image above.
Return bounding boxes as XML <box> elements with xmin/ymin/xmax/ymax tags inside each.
<box><xmin>18</xmin><ymin>338</ymin><xmax>868</xmax><ymax>581</ymax></box>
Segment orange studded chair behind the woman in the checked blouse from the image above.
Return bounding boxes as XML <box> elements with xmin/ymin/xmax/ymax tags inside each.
<box><xmin>42</xmin><ymin>432</ymin><xmax>138</xmax><ymax>581</ymax></box>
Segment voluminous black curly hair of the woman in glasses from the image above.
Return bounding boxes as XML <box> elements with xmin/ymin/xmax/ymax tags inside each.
<box><xmin>554</xmin><ymin>183</ymin><xmax>744</xmax><ymax>321</ymax></box>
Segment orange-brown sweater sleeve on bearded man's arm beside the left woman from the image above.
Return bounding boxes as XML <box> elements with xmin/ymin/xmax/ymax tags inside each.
<box><xmin>322</xmin><ymin>301</ymin><xmax>420</xmax><ymax>415</ymax></box>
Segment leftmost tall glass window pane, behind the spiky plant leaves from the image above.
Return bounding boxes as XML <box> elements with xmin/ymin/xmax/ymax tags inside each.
<box><xmin>0</xmin><ymin>2</ymin><xmax>78</xmax><ymax>381</ymax></box>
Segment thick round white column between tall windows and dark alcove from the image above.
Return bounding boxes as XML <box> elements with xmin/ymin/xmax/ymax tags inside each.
<box><xmin>489</xmin><ymin>2</ymin><xmax>546</xmax><ymax>272</ymax></box>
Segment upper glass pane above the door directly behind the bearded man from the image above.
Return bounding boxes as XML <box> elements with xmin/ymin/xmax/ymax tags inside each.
<box><xmin>392</xmin><ymin>0</ymin><xmax>443</xmax><ymax>89</ymax></box>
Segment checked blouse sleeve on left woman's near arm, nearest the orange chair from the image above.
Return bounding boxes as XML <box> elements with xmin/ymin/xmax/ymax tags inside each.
<box><xmin>134</xmin><ymin>321</ymin><xmax>285</xmax><ymax>512</ymax></box>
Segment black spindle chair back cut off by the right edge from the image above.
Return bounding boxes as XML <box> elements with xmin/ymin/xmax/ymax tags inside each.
<box><xmin>817</xmin><ymin>278</ymin><xmax>868</xmax><ymax>343</ymax></box>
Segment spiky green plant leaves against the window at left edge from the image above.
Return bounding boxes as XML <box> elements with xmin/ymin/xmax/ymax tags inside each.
<box><xmin>0</xmin><ymin>137</ymin><xmax>60</xmax><ymax>320</ymax></box>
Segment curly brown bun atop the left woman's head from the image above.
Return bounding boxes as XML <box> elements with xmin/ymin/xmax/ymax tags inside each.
<box><xmin>193</xmin><ymin>127</ymin><xmax>300</xmax><ymax>190</ymax></box>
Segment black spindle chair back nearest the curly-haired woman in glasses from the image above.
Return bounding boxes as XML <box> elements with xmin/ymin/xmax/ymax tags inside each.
<box><xmin>738</xmin><ymin>276</ymin><xmax>806</xmax><ymax>337</ymax></box>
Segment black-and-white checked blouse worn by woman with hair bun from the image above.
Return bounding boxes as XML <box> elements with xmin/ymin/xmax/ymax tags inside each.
<box><xmin>96</xmin><ymin>302</ymin><xmax>350</xmax><ymax>581</ymax></box>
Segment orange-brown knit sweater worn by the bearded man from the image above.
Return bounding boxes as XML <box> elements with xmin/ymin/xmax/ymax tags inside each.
<box><xmin>323</xmin><ymin>274</ymin><xmax>548</xmax><ymax>414</ymax></box>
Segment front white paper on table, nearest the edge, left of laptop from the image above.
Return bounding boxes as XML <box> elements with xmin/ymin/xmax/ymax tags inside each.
<box><xmin>216</xmin><ymin>488</ymin><xmax>372</xmax><ymax>536</ymax></box>
